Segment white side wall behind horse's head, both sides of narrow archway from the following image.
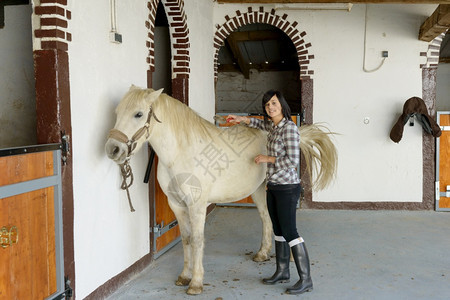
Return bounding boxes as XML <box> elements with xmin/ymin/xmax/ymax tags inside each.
<box><xmin>69</xmin><ymin>0</ymin><xmax>214</xmax><ymax>299</ymax></box>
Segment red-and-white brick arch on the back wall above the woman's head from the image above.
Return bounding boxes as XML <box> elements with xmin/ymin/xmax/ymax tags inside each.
<box><xmin>214</xmin><ymin>7</ymin><xmax>314</xmax><ymax>81</ymax></box>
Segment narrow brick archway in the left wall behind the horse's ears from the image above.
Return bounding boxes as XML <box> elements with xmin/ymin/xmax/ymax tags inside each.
<box><xmin>145</xmin><ymin>0</ymin><xmax>190</xmax><ymax>105</ymax></box>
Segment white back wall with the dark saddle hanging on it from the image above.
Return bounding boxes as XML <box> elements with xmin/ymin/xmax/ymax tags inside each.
<box><xmin>214</xmin><ymin>4</ymin><xmax>436</xmax><ymax>202</ymax></box>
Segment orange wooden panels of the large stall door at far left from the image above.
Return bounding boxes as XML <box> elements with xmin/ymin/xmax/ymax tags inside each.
<box><xmin>0</xmin><ymin>152</ymin><xmax>57</xmax><ymax>300</ymax></box>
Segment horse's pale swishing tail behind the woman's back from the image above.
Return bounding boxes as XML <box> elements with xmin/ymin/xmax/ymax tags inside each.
<box><xmin>299</xmin><ymin>124</ymin><xmax>338</xmax><ymax>190</ymax></box>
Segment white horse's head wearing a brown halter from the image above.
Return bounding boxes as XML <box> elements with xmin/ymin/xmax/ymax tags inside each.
<box><xmin>105</xmin><ymin>85</ymin><xmax>163</xmax><ymax>164</ymax></box>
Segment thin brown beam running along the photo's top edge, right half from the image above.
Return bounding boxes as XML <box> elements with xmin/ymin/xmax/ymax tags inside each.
<box><xmin>217</xmin><ymin>0</ymin><xmax>450</xmax><ymax>4</ymax></box>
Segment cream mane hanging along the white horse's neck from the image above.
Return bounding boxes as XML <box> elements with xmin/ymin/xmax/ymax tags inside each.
<box><xmin>153</xmin><ymin>94</ymin><xmax>219</xmax><ymax>144</ymax></box>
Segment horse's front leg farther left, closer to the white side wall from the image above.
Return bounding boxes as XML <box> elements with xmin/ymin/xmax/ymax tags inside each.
<box><xmin>169</xmin><ymin>199</ymin><xmax>192</xmax><ymax>286</ymax></box>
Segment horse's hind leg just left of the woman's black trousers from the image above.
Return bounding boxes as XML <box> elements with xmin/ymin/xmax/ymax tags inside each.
<box><xmin>252</xmin><ymin>183</ymin><xmax>272</xmax><ymax>261</ymax></box>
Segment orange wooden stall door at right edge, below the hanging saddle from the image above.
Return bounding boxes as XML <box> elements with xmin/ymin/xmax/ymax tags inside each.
<box><xmin>436</xmin><ymin>112</ymin><xmax>450</xmax><ymax>211</ymax></box>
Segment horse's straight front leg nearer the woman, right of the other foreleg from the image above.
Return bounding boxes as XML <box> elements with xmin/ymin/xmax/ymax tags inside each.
<box><xmin>187</xmin><ymin>200</ymin><xmax>207</xmax><ymax>295</ymax></box>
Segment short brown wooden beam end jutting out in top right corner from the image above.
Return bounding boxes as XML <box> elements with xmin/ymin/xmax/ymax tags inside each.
<box><xmin>419</xmin><ymin>4</ymin><xmax>450</xmax><ymax>42</ymax></box>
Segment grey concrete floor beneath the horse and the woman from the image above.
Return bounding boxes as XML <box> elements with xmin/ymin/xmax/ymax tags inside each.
<box><xmin>108</xmin><ymin>207</ymin><xmax>450</xmax><ymax>300</ymax></box>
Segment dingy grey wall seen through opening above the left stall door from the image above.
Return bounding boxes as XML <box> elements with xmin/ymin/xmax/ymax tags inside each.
<box><xmin>0</xmin><ymin>5</ymin><xmax>36</xmax><ymax>148</ymax></box>
